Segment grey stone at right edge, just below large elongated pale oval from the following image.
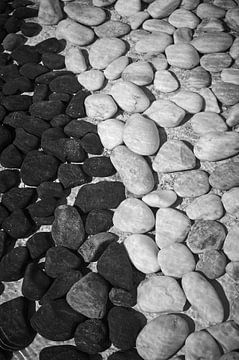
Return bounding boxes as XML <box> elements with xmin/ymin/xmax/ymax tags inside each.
<box><xmin>209</xmin><ymin>162</ymin><xmax>239</xmax><ymax>190</ymax></box>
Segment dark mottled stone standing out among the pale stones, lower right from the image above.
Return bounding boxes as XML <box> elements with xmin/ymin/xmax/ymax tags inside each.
<box><xmin>186</xmin><ymin>220</ymin><xmax>226</xmax><ymax>254</ymax></box>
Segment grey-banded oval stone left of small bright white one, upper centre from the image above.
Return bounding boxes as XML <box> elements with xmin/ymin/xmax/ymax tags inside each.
<box><xmin>121</xmin><ymin>61</ymin><xmax>154</xmax><ymax>86</ymax></box>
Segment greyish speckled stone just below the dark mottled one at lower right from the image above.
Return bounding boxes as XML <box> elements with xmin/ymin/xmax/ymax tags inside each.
<box><xmin>196</xmin><ymin>250</ymin><xmax>227</xmax><ymax>280</ymax></box>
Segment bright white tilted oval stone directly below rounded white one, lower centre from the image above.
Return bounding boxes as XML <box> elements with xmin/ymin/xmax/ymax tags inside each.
<box><xmin>124</xmin><ymin>234</ymin><xmax>160</xmax><ymax>274</ymax></box>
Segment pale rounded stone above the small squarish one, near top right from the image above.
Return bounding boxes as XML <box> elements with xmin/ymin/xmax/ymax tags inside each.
<box><xmin>168</xmin><ymin>9</ymin><xmax>200</xmax><ymax>29</ymax></box>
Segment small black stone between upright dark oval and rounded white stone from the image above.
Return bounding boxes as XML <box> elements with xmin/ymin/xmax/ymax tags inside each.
<box><xmin>85</xmin><ymin>210</ymin><xmax>113</xmax><ymax>235</ymax></box>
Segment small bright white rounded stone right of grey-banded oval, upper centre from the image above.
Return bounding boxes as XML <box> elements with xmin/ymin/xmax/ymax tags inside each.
<box><xmin>154</xmin><ymin>70</ymin><xmax>179</xmax><ymax>93</ymax></box>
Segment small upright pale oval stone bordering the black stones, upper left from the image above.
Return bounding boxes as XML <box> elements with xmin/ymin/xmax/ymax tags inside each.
<box><xmin>65</xmin><ymin>46</ymin><xmax>87</xmax><ymax>74</ymax></box>
